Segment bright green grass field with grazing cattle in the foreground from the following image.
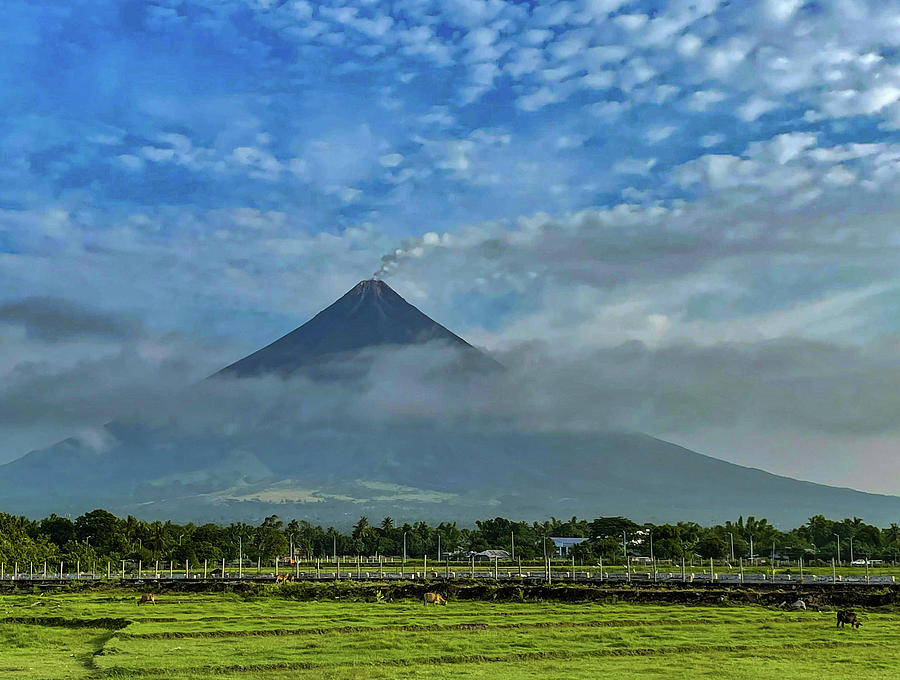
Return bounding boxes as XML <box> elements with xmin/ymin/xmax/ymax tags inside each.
<box><xmin>0</xmin><ymin>586</ymin><xmax>900</xmax><ymax>680</ymax></box>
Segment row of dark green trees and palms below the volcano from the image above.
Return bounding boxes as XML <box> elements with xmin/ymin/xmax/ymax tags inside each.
<box><xmin>0</xmin><ymin>509</ymin><xmax>900</xmax><ymax>566</ymax></box>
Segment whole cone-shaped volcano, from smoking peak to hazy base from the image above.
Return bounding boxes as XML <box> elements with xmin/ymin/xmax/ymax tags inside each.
<box><xmin>0</xmin><ymin>280</ymin><xmax>900</xmax><ymax>525</ymax></box>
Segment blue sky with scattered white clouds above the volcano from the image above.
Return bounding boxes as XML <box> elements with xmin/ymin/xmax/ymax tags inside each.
<box><xmin>0</xmin><ymin>0</ymin><xmax>900</xmax><ymax>493</ymax></box>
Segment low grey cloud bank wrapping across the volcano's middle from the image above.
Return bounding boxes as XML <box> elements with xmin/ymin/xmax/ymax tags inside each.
<box><xmin>0</xmin><ymin>326</ymin><xmax>900</xmax><ymax>493</ymax></box>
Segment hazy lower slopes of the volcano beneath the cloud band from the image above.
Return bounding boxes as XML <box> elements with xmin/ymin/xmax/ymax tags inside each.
<box><xmin>0</xmin><ymin>425</ymin><xmax>900</xmax><ymax>526</ymax></box>
